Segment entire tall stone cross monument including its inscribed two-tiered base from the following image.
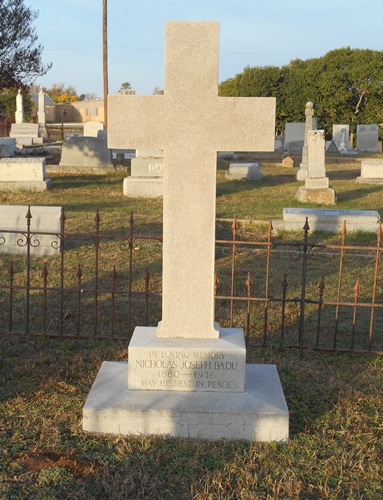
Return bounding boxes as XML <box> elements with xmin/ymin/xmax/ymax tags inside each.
<box><xmin>83</xmin><ymin>22</ymin><xmax>288</xmax><ymax>441</ymax></box>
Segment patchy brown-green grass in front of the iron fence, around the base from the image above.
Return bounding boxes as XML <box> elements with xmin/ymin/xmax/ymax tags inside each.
<box><xmin>0</xmin><ymin>336</ymin><xmax>383</xmax><ymax>499</ymax></box>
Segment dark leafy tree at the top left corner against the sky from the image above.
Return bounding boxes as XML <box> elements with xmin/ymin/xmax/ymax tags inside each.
<box><xmin>0</xmin><ymin>0</ymin><xmax>52</xmax><ymax>90</ymax></box>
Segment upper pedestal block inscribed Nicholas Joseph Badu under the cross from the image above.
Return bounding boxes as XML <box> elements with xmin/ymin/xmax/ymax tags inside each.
<box><xmin>128</xmin><ymin>328</ymin><xmax>245</xmax><ymax>392</ymax></box>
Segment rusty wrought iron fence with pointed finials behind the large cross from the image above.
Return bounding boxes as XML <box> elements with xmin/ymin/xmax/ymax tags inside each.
<box><xmin>0</xmin><ymin>208</ymin><xmax>383</xmax><ymax>354</ymax></box>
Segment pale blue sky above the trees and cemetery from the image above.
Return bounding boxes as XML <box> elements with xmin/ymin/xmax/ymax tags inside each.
<box><xmin>32</xmin><ymin>0</ymin><xmax>383</xmax><ymax>97</ymax></box>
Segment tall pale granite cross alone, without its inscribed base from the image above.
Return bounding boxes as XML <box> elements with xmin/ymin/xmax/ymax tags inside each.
<box><xmin>108</xmin><ymin>22</ymin><xmax>275</xmax><ymax>339</ymax></box>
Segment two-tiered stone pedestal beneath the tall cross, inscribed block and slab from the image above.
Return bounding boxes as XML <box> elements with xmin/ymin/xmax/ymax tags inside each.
<box><xmin>83</xmin><ymin>328</ymin><xmax>289</xmax><ymax>442</ymax></box>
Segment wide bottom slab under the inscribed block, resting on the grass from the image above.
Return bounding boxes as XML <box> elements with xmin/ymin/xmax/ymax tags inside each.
<box><xmin>83</xmin><ymin>361</ymin><xmax>289</xmax><ymax>442</ymax></box>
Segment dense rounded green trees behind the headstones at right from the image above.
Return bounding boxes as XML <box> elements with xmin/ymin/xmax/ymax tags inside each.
<box><xmin>220</xmin><ymin>47</ymin><xmax>383</xmax><ymax>136</ymax></box>
